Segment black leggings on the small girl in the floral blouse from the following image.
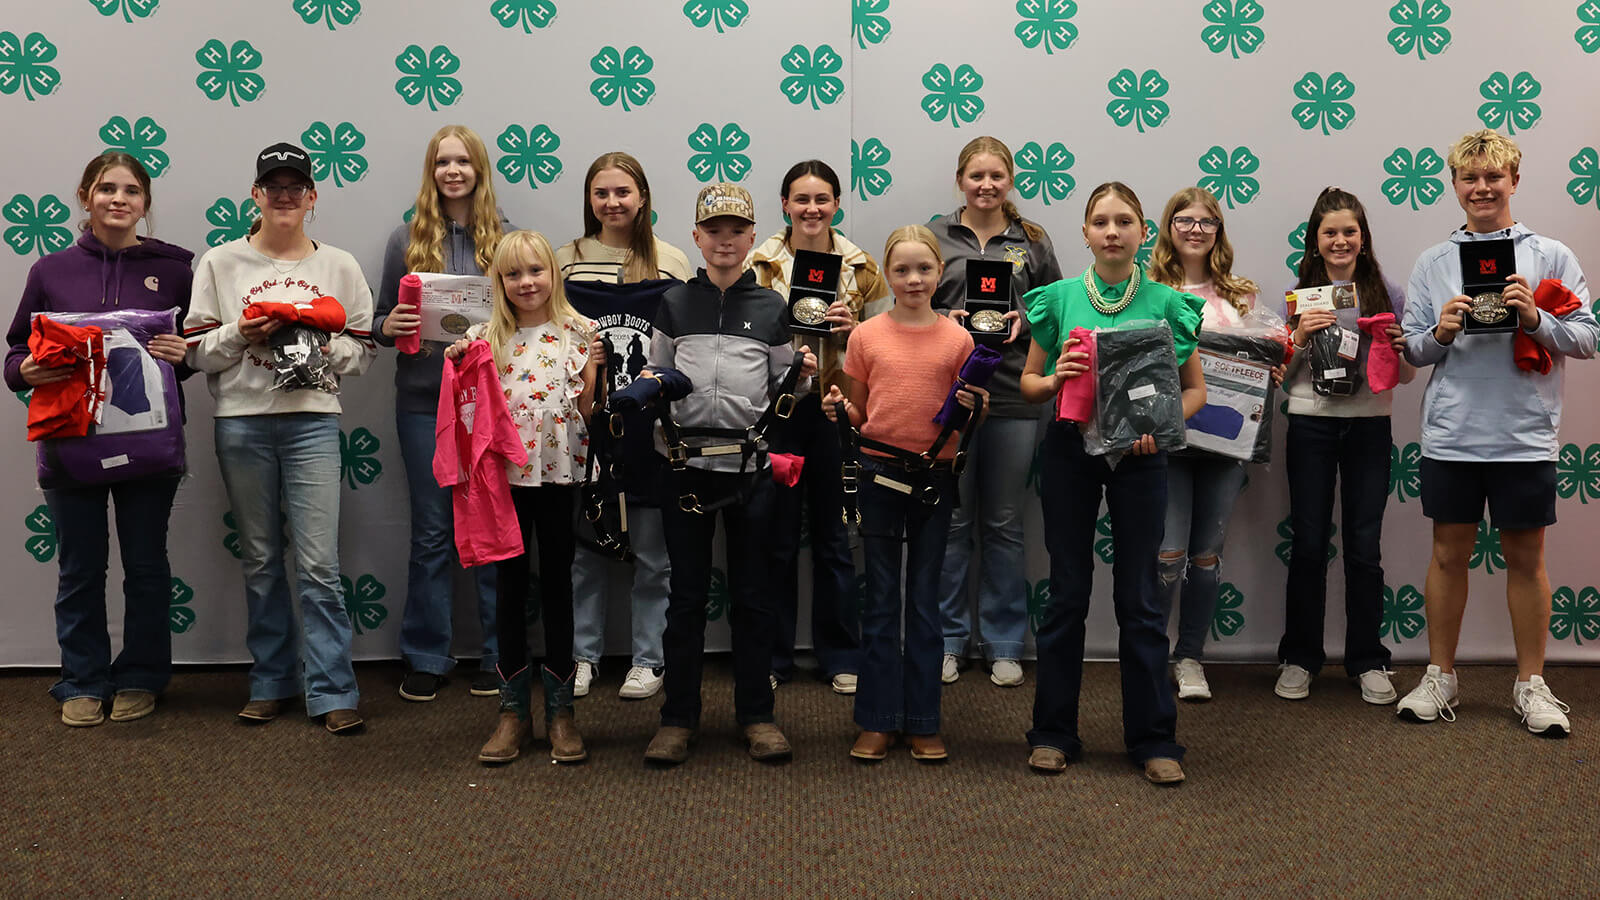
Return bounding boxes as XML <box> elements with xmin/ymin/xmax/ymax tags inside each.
<box><xmin>494</xmin><ymin>484</ymin><xmax>578</xmax><ymax>681</ymax></box>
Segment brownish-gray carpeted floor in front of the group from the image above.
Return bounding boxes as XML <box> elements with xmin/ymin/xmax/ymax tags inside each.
<box><xmin>0</xmin><ymin>660</ymin><xmax>1600</xmax><ymax>898</ymax></box>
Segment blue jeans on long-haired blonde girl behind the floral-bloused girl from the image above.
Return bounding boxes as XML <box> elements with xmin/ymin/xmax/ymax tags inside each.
<box><xmin>395</xmin><ymin>410</ymin><xmax>499</xmax><ymax>674</ymax></box>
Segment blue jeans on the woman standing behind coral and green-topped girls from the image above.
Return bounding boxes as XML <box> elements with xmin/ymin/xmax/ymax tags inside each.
<box><xmin>939</xmin><ymin>418</ymin><xmax>1038</xmax><ymax>661</ymax></box>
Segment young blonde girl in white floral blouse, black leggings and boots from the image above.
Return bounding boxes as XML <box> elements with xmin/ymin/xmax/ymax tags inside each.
<box><xmin>446</xmin><ymin>231</ymin><xmax>598</xmax><ymax>762</ymax></box>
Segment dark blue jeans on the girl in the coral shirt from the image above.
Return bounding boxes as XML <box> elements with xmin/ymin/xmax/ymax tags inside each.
<box><xmin>856</xmin><ymin>458</ymin><xmax>955</xmax><ymax>735</ymax></box>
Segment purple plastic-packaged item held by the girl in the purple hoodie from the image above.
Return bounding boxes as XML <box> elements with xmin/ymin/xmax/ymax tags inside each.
<box><xmin>37</xmin><ymin>307</ymin><xmax>184</xmax><ymax>487</ymax></box>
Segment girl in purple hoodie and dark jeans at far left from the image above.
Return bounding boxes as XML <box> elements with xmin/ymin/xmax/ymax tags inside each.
<box><xmin>5</xmin><ymin>152</ymin><xmax>194</xmax><ymax>725</ymax></box>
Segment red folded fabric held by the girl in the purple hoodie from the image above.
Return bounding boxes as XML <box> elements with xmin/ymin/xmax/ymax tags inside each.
<box><xmin>27</xmin><ymin>315</ymin><xmax>106</xmax><ymax>440</ymax></box>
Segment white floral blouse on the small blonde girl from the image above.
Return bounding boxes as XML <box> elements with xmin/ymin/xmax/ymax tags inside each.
<box><xmin>466</xmin><ymin>319</ymin><xmax>598</xmax><ymax>487</ymax></box>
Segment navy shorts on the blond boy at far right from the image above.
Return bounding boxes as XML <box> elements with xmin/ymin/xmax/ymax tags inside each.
<box><xmin>1421</xmin><ymin>456</ymin><xmax>1555</xmax><ymax>532</ymax></box>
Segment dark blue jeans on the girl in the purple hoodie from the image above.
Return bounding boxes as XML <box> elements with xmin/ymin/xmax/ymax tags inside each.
<box><xmin>45</xmin><ymin>476</ymin><xmax>178</xmax><ymax>703</ymax></box>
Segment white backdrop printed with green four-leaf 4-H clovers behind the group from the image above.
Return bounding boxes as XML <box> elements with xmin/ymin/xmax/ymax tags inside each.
<box><xmin>0</xmin><ymin>0</ymin><xmax>1600</xmax><ymax>665</ymax></box>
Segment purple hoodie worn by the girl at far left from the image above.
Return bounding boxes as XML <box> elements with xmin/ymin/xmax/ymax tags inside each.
<box><xmin>5</xmin><ymin>231</ymin><xmax>195</xmax><ymax>396</ymax></box>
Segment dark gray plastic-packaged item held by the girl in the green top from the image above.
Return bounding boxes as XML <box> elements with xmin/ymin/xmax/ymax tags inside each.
<box><xmin>1083</xmin><ymin>320</ymin><xmax>1187</xmax><ymax>464</ymax></box>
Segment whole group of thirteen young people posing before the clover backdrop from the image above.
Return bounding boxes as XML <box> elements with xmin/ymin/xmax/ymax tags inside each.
<box><xmin>6</xmin><ymin>127</ymin><xmax>1600</xmax><ymax>785</ymax></box>
